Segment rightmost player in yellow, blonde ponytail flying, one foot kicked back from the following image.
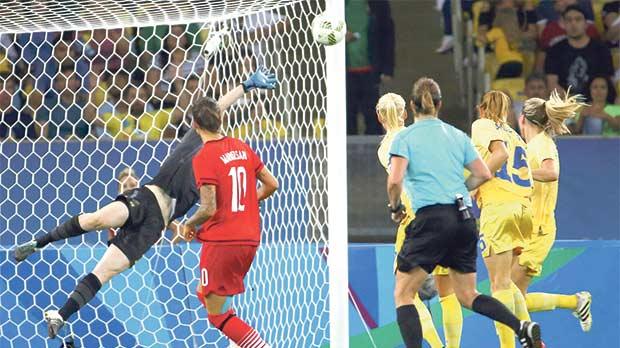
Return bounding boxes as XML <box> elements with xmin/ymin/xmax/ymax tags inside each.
<box><xmin>512</xmin><ymin>91</ymin><xmax>592</xmax><ymax>331</ymax></box>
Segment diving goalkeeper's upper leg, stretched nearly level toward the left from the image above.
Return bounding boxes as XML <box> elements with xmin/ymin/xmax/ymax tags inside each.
<box><xmin>14</xmin><ymin>201</ymin><xmax>129</xmax><ymax>262</ymax></box>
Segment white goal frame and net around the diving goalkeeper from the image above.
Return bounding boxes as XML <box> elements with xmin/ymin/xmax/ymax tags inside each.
<box><xmin>0</xmin><ymin>0</ymin><xmax>349</xmax><ymax>348</ymax></box>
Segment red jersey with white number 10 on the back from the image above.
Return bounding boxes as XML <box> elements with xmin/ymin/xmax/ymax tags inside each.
<box><xmin>193</xmin><ymin>137</ymin><xmax>264</xmax><ymax>246</ymax></box>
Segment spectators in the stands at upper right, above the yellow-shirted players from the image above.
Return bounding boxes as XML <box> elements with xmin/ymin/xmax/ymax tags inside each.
<box><xmin>437</xmin><ymin>0</ymin><xmax>620</xmax><ymax>135</ymax></box>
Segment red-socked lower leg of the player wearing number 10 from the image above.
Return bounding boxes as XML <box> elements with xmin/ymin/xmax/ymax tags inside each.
<box><xmin>199</xmin><ymin>292</ymin><xmax>269</xmax><ymax>348</ymax></box>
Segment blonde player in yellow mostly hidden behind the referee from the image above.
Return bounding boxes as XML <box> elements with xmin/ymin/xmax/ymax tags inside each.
<box><xmin>376</xmin><ymin>93</ymin><xmax>463</xmax><ymax>348</ymax></box>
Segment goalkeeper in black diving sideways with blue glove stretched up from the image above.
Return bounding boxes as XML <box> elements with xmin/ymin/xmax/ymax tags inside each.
<box><xmin>14</xmin><ymin>68</ymin><xmax>278</xmax><ymax>338</ymax></box>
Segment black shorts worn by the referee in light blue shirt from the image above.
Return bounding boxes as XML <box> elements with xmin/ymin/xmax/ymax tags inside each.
<box><xmin>397</xmin><ymin>204</ymin><xmax>478</xmax><ymax>273</ymax></box>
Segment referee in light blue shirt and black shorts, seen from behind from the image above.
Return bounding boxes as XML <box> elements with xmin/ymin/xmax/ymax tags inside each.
<box><xmin>387</xmin><ymin>78</ymin><xmax>542</xmax><ymax>348</ymax></box>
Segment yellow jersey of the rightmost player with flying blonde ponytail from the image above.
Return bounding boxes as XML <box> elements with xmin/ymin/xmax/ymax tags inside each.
<box><xmin>527</xmin><ymin>132</ymin><xmax>560</xmax><ymax>233</ymax></box>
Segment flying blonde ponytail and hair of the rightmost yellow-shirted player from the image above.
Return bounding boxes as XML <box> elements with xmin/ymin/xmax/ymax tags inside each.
<box><xmin>523</xmin><ymin>88</ymin><xmax>587</xmax><ymax>136</ymax></box>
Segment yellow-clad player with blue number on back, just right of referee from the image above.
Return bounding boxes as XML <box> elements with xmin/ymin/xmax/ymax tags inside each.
<box><xmin>472</xmin><ymin>91</ymin><xmax>532</xmax><ymax>348</ymax></box>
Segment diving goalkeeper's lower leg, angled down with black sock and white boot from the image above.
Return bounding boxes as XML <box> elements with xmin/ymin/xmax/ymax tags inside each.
<box><xmin>45</xmin><ymin>244</ymin><xmax>131</xmax><ymax>338</ymax></box>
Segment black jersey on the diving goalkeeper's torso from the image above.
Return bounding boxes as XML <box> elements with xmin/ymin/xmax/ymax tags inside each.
<box><xmin>147</xmin><ymin>129</ymin><xmax>203</xmax><ymax>220</ymax></box>
